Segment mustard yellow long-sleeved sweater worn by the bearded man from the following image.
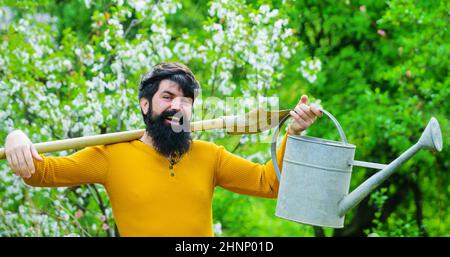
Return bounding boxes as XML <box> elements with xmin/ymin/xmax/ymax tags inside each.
<box><xmin>25</xmin><ymin>135</ymin><xmax>286</xmax><ymax>236</ymax></box>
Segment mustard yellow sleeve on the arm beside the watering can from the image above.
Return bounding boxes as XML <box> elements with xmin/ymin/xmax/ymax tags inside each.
<box><xmin>215</xmin><ymin>133</ymin><xmax>287</xmax><ymax>198</ymax></box>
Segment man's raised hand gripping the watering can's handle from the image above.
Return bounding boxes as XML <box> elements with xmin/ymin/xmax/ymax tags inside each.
<box><xmin>288</xmin><ymin>95</ymin><xmax>322</xmax><ymax>135</ymax></box>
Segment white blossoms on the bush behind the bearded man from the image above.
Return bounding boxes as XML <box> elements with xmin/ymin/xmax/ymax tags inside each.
<box><xmin>0</xmin><ymin>0</ymin><xmax>302</xmax><ymax>236</ymax></box>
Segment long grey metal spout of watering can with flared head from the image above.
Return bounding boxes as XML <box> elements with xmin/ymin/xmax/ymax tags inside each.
<box><xmin>339</xmin><ymin>117</ymin><xmax>443</xmax><ymax>217</ymax></box>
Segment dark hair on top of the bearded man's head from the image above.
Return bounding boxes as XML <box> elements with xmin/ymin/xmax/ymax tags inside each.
<box><xmin>139</xmin><ymin>62</ymin><xmax>200</xmax><ymax>115</ymax></box>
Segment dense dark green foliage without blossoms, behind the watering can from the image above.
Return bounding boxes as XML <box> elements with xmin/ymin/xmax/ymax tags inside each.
<box><xmin>284</xmin><ymin>0</ymin><xmax>450</xmax><ymax>235</ymax></box>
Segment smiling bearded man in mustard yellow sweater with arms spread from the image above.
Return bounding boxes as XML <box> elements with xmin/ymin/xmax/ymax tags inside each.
<box><xmin>5</xmin><ymin>63</ymin><xmax>321</xmax><ymax>236</ymax></box>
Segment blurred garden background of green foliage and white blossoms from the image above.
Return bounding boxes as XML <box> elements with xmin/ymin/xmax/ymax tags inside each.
<box><xmin>0</xmin><ymin>0</ymin><xmax>450</xmax><ymax>237</ymax></box>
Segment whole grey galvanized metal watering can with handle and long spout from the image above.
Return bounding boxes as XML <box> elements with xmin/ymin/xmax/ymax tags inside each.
<box><xmin>271</xmin><ymin>109</ymin><xmax>442</xmax><ymax>228</ymax></box>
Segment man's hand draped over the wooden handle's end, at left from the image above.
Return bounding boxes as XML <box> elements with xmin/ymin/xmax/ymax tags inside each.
<box><xmin>5</xmin><ymin>130</ymin><xmax>42</xmax><ymax>178</ymax></box>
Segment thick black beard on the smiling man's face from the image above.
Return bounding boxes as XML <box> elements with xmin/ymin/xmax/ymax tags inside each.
<box><xmin>144</xmin><ymin>109</ymin><xmax>192</xmax><ymax>159</ymax></box>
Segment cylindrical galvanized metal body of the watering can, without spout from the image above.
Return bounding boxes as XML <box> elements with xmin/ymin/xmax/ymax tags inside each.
<box><xmin>275</xmin><ymin>135</ymin><xmax>355</xmax><ymax>228</ymax></box>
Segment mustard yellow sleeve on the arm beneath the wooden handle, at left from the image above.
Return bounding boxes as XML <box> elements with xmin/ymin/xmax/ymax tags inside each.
<box><xmin>24</xmin><ymin>146</ymin><xmax>109</xmax><ymax>187</ymax></box>
